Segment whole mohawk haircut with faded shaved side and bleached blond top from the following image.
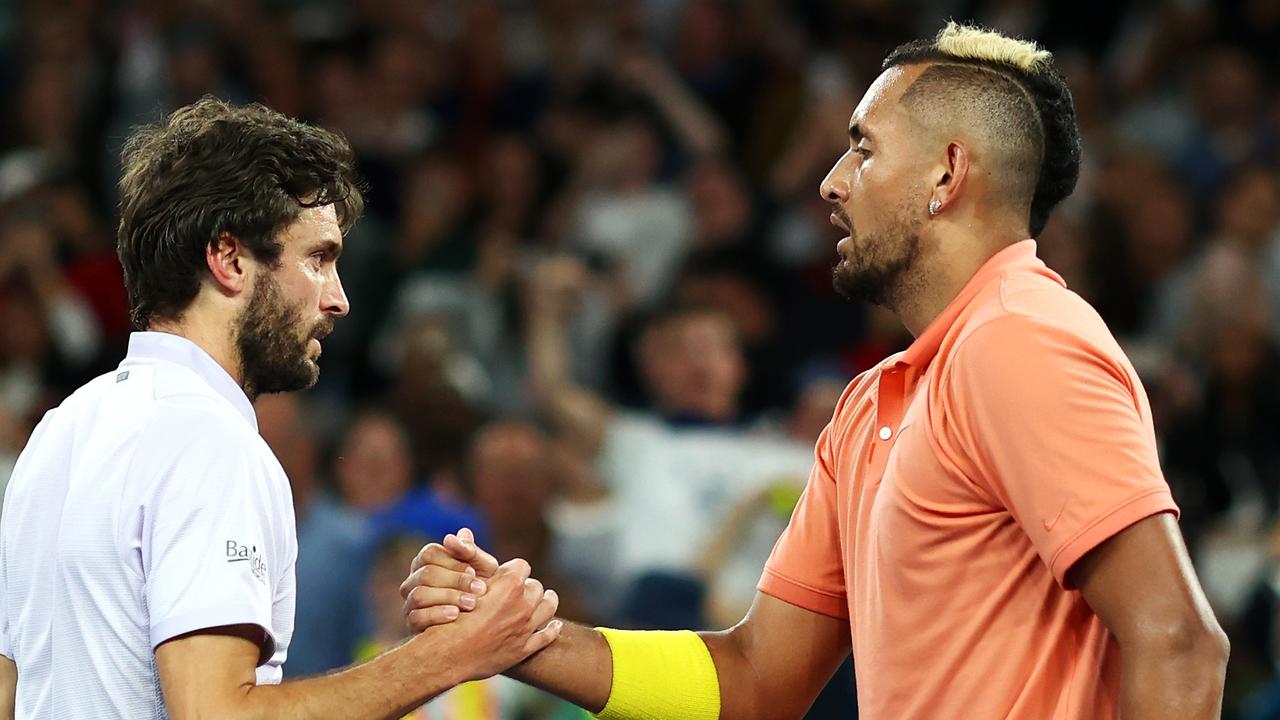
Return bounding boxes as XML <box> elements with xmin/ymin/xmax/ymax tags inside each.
<box><xmin>884</xmin><ymin>22</ymin><xmax>1080</xmax><ymax>237</ymax></box>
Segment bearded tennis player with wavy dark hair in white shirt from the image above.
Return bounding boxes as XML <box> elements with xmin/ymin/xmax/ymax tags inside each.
<box><xmin>0</xmin><ymin>99</ymin><xmax>561</xmax><ymax>720</ymax></box>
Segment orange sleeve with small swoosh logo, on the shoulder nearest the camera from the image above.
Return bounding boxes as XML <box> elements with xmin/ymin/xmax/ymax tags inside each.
<box><xmin>947</xmin><ymin>315</ymin><xmax>1178</xmax><ymax>587</ymax></box>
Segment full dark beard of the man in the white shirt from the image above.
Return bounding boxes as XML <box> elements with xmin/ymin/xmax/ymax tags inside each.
<box><xmin>236</xmin><ymin>274</ymin><xmax>333</xmax><ymax>400</ymax></box>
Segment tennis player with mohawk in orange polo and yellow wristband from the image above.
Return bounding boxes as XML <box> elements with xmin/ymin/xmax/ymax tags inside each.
<box><xmin>403</xmin><ymin>24</ymin><xmax>1228</xmax><ymax>720</ymax></box>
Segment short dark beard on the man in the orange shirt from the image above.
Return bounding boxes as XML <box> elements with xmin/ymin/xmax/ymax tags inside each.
<box><xmin>831</xmin><ymin>223</ymin><xmax>920</xmax><ymax>310</ymax></box>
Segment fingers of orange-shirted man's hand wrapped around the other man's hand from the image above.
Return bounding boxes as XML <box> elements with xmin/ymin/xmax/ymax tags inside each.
<box><xmin>401</xmin><ymin>528</ymin><xmax>501</xmax><ymax>633</ymax></box>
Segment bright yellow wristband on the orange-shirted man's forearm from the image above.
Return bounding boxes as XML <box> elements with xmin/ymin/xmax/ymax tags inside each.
<box><xmin>596</xmin><ymin>628</ymin><xmax>719</xmax><ymax>720</ymax></box>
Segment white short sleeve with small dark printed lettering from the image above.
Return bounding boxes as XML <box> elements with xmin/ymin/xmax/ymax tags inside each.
<box><xmin>142</xmin><ymin>425</ymin><xmax>285</xmax><ymax>662</ymax></box>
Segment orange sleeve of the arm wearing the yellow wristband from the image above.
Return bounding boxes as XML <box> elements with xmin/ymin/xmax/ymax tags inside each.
<box><xmin>756</xmin><ymin>424</ymin><xmax>849</xmax><ymax>619</ymax></box>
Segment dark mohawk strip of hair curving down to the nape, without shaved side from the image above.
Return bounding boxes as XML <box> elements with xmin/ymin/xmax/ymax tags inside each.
<box><xmin>883</xmin><ymin>23</ymin><xmax>1080</xmax><ymax>237</ymax></box>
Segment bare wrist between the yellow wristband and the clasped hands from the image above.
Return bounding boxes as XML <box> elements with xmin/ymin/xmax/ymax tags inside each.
<box><xmin>506</xmin><ymin>624</ymin><xmax>613</xmax><ymax>712</ymax></box>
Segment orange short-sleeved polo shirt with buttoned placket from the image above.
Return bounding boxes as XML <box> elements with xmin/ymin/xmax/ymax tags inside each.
<box><xmin>759</xmin><ymin>240</ymin><xmax>1178</xmax><ymax>720</ymax></box>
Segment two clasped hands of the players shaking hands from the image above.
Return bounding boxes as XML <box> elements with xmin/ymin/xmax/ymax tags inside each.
<box><xmin>401</xmin><ymin>528</ymin><xmax>563</xmax><ymax>682</ymax></box>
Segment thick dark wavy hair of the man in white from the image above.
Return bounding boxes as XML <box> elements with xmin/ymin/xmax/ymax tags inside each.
<box><xmin>116</xmin><ymin>97</ymin><xmax>364</xmax><ymax>329</ymax></box>
